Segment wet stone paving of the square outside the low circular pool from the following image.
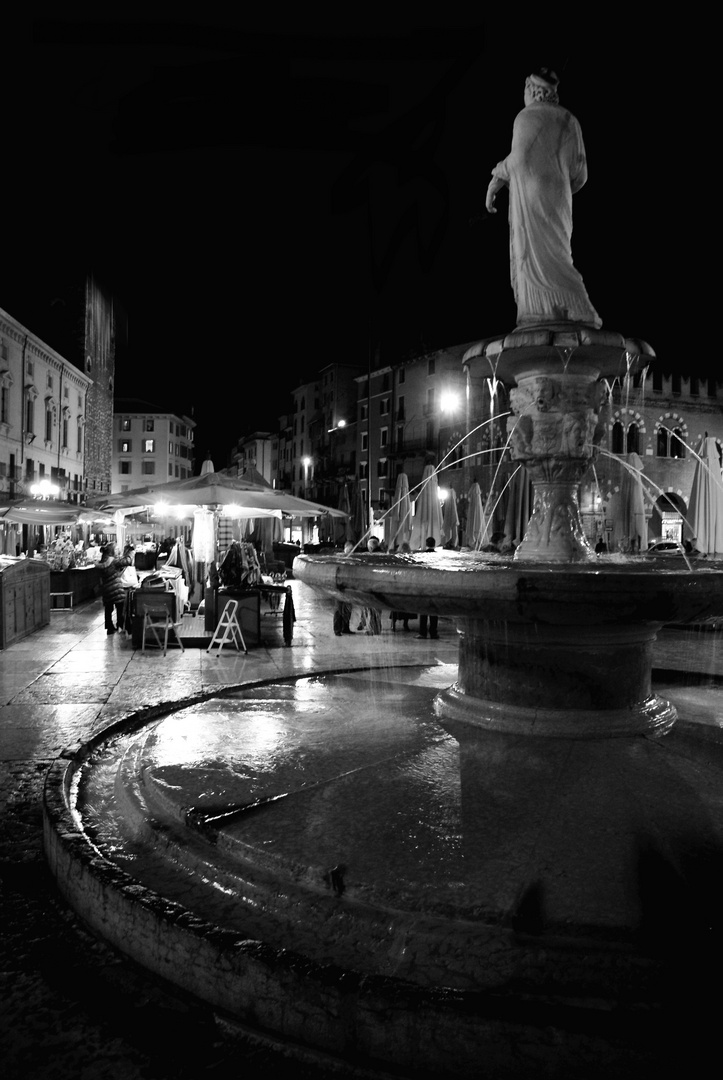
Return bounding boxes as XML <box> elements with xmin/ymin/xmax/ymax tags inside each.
<box><xmin>0</xmin><ymin>581</ymin><xmax>456</xmax><ymax>1080</ymax></box>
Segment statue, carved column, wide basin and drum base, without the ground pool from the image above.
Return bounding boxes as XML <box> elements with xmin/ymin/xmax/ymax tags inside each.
<box><xmin>294</xmin><ymin>68</ymin><xmax>723</xmax><ymax>738</ymax></box>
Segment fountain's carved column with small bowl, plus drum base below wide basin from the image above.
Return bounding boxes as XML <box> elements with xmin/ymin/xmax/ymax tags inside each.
<box><xmin>438</xmin><ymin>324</ymin><xmax>675</xmax><ymax>738</ymax></box>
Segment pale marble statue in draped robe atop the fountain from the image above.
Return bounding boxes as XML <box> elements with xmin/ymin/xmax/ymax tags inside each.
<box><xmin>486</xmin><ymin>68</ymin><xmax>602</xmax><ymax>328</ymax></box>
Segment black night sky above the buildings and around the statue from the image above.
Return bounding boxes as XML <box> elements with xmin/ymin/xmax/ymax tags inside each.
<box><xmin>0</xmin><ymin>12</ymin><xmax>708</xmax><ymax>467</ymax></box>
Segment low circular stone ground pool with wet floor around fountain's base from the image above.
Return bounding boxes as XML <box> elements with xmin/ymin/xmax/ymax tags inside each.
<box><xmin>46</xmin><ymin>664</ymin><xmax>723</xmax><ymax>1077</ymax></box>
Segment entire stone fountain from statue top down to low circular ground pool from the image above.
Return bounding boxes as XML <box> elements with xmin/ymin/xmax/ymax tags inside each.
<box><xmin>46</xmin><ymin>72</ymin><xmax>723</xmax><ymax>1080</ymax></box>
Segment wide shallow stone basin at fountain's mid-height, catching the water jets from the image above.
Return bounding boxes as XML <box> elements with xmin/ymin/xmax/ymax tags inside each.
<box><xmin>294</xmin><ymin>552</ymin><xmax>723</xmax><ymax>625</ymax></box>
